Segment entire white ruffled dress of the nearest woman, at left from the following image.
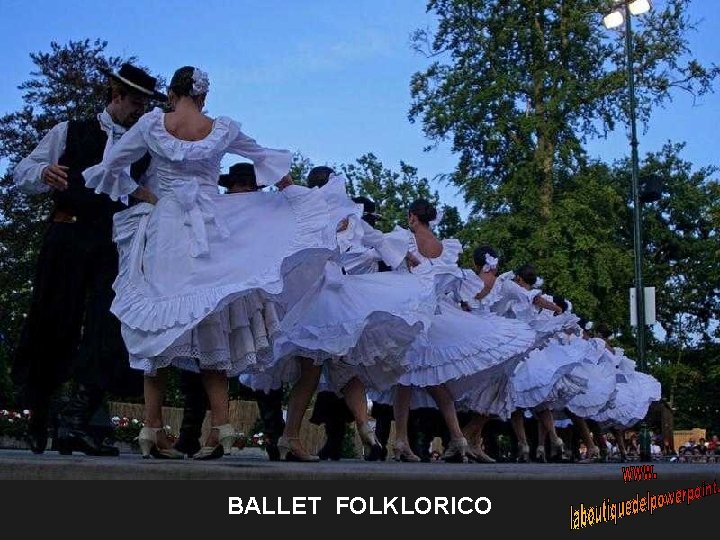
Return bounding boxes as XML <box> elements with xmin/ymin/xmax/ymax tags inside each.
<box><xmin>83</xmin><ymin>109</ymin><xmax>359</xmax><ymax>375</ymax></box>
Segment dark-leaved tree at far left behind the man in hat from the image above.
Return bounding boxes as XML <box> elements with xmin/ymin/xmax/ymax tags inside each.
<box><xmin>0</xmin><ymin>40</ymin><xmax>152</xmax><ymax>402</ymax></box>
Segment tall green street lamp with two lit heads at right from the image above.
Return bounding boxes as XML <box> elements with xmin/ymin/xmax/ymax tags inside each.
<box><xmin>603</xmin><ymin>0</ymin><xmax>652</xmax><ymax>461</ymax></box>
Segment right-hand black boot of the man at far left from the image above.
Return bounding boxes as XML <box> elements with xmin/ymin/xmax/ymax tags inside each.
<box><xmin>55</xmin><ymin>384</ymin><xmax>120</xmax><ymax>456</ymax></box>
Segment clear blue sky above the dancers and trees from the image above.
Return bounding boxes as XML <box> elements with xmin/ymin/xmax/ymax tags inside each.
<box><xmin>0</xmin><ymin>0</ymin><xmax>720</xmax><ymax>215</ymax></box>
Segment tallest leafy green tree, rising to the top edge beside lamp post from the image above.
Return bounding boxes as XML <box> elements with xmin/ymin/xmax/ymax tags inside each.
<box><xmin>409</xmin><ymin>0</ymin><xmax>720</xmax><ymax>225</ymax></box>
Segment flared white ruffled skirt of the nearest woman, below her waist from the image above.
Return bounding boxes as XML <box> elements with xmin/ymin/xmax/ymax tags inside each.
<box><xmin>112</xmin><ymin>188</ymin><xmax>357</xmax><ymax>375</ymax></box>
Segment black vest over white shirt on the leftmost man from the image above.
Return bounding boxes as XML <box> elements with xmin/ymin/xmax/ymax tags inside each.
<box><xmin>53</xmin><ymin>119</ymin><xmax>150</xmax><ymax>229</ymax></box>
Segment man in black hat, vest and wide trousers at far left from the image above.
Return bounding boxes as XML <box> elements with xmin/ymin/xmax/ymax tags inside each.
<box><xmin>13</xmin><ymin>64</ymin><xmax>166</xmax><ymax>455</ymax></box>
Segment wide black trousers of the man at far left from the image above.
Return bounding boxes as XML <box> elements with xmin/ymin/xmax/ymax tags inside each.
<box><xmin>12</xmin><ymin>222</ymin><xmax>142</xmax><ymax>408</ymax></box>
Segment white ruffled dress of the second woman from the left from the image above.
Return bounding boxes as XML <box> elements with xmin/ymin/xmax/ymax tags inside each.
<box><xmin>241</xmin><ymin>189</ymin><xmax>436</xmax><ymax>392</ymax></box>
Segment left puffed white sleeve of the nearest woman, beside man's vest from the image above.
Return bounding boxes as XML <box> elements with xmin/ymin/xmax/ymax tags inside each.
<box><xmin>83</xmin><ymin>115</ymin><xmax>148</xmax><ymax>201</ymax></box>
